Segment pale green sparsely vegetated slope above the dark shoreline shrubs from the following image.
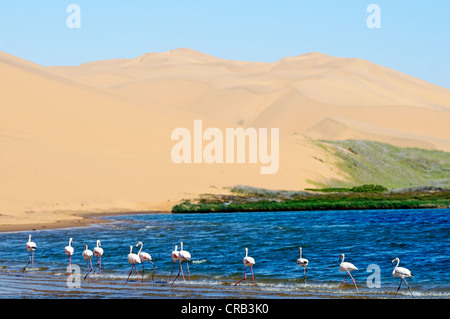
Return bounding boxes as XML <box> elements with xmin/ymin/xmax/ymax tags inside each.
<box><xmin>314</xmin><ymin>140</ymin><xmax>450</xmax><ymax>189</ymax></box>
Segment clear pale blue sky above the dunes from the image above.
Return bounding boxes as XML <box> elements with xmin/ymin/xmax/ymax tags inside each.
<box><xmin>0</xmin><ymin>0</ymin><xmax>450</xmax><ymax>88</ymax></box>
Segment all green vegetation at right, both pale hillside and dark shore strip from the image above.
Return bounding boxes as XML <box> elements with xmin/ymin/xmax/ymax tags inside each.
<box><xmin>172</xmin><ymin>140</ymin><xmax>450</xmax><ymax>213</ymax></box>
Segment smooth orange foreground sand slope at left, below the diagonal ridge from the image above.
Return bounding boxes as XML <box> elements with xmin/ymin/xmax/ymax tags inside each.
<box><xmin>0</xmin><ymin>53</ymin><xmax>333</xmax><ymax>230</ymax></box>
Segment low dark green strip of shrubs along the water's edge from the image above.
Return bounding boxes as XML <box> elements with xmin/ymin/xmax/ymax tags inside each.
<box><xmin>172</xmin><ymin>186</ymin><xmax>450</xmax><ymax>213</ymax></box>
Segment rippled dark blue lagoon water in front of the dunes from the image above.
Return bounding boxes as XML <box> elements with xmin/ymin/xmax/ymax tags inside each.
<box><xmin>0</xmin><ymin>209</ymin><xmax>450</xmax><ymax>298</ymax></box>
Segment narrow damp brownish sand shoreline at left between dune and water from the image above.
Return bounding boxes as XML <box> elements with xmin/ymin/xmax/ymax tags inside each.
<box><xmin>0</xmin><ymin>211</ymin><xmax>171</xmax><ymax>233</ymax></box>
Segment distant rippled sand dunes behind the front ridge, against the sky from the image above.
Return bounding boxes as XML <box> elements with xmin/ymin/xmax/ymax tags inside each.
<box><xmin>51</xmin><ymin>49</ymin><xmax>450</xmax><ymax>150</ymax></box>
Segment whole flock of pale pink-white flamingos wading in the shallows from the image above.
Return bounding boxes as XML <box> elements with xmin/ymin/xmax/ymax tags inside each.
<box><xmin>23</xmin><ymin>234</ymin><xmax>414</xmax><ymax>298</ymax></box>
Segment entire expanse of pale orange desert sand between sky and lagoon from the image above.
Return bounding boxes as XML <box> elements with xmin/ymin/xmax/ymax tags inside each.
<box><xmin>0</xmin><ymin>48</ymin><xmax>450</xmax><ymax>231</ymax></box>
